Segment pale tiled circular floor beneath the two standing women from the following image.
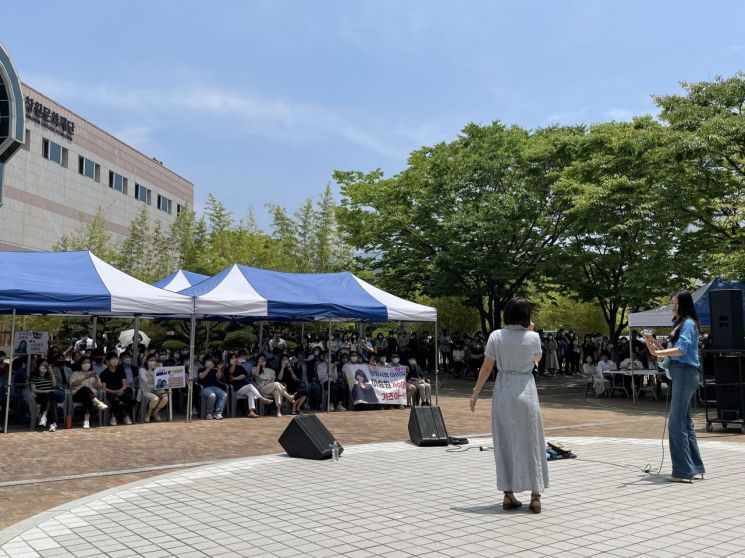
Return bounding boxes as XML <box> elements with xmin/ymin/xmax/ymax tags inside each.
<box><xmin>0</xmin><ymin>437</ymin><xmax>745</xmax><ymax>558</ymax></box>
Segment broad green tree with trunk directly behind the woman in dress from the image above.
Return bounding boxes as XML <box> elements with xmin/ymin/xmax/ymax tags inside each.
<box><xmin>334</xmin><ymin>123</ymin><xmax>583</xmax><ymax>334</ymax></box>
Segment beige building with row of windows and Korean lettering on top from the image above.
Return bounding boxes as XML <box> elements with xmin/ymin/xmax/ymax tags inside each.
<box><xmin>0</xmin><ymin>84</ymin><xmax>194</xmax><ymax>251</ymax></box>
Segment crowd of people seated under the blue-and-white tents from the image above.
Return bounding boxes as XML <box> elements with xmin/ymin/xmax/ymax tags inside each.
<box><xmin>0</xmin><ymin>329</ymin><xmax>442</xmax><ymax>431</ymax></box>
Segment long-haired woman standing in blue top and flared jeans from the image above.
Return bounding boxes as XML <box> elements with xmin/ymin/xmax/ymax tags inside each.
<box><xmin>644</xmin><ymin>291</ymin><xmax>705</xmax><ymax>483</ymax></box>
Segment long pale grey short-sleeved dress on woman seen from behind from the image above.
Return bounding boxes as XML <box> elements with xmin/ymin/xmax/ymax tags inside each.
<box><xmin>484</xmin><ymin>326</ymin><xmax>548</xmax><ymax>492</ymax></box>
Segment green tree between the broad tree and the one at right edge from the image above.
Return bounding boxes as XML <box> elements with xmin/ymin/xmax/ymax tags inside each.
<box><xmin>559</xmin><ymin>117</ymin><xmax>691</xmax><ymax>343</ymax></box>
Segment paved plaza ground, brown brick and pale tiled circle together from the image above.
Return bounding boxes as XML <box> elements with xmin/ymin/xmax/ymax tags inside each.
<box><xmin>0</xmin><ymin>378</ymin><xmax>745</xmax><ymax>557</ymax></box>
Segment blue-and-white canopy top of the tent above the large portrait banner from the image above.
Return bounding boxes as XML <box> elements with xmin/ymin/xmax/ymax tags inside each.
<box><xmin>180</xmin><ymin>264</ymin><xmax>437</xmax><ymax>322</ymax></box>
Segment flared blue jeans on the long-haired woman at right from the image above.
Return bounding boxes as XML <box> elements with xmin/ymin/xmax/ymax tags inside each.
<box><xmin>668</xmin><ymin>362</ymin><xmax>704</xmax><ymax>479</ymax></box>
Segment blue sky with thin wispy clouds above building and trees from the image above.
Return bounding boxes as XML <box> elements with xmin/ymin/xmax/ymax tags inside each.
<box><xmin>0</xmin><ymin>0</ymin><xmax>745</xmax><ymax>230</ymax></box>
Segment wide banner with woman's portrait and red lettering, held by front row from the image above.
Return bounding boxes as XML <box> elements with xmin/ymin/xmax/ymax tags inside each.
<box><xmin>343</xmin><ymin>364</ymin><xmax>406</xmax><ymax>405</ymax></box>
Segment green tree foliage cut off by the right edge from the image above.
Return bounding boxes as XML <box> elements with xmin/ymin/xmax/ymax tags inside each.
<box><xmin>655</xmin><ymin>72</ymin><xmax>745</xmax><ymax>279</ymax></box>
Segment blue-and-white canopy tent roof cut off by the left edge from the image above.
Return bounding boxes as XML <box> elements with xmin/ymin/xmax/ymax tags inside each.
<box><xmin>0</xmin><ymin>251</ymin><xmax>194</xmax><ymax>431</ymax></box>
